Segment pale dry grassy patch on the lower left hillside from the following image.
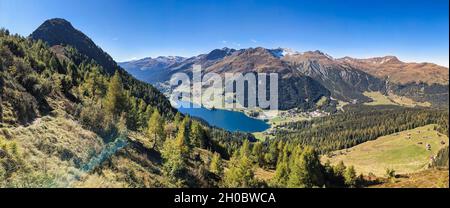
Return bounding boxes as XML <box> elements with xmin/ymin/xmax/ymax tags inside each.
<box><xmin>0</xmin><ymin>111</ymin><xmax>104</xmax><ymax>187</ymax></box>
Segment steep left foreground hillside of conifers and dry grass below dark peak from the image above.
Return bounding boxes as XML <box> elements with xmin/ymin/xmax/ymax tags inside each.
<box><xmin>0</xmin><ymin>20</ymin><xmax>362</xmax><ymax>187</ymax></box>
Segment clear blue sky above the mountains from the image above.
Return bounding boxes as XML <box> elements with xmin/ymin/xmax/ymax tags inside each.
<box><xmin>0</xmin><ymin>0</ymin><xmax>449</xmax><ymax>66</ymax></box>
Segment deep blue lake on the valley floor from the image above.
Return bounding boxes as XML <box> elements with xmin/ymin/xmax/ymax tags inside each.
<box><xmin>178</xmin><ymin>103</ymin><xmax>270</xmax><ymax>133</ymax></box>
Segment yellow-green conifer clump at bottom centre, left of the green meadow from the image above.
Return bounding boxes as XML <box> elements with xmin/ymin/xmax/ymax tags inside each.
<box><xmin>210</xmin><ymin>141</ymin><xmax>365</xmax><ymax>188</ymax></box>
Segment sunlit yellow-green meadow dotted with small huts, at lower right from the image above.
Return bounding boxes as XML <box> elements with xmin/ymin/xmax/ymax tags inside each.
<box><xmin>322</xmin><ymin>125</ymin><xmax>449</xmax><ymax>176</ymax></box>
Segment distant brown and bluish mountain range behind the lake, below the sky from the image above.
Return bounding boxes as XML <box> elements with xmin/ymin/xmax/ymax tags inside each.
<box><xmin>119</xmin><ymin>47</ymin><xmax>449</xmax><ymax>109</ymax></box>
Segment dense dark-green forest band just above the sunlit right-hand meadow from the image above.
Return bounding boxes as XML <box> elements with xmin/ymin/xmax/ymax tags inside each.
<box><xmin>276</xmin><ymin>106</ymin><xmax>448</xmax><ymax>153</ymax></box>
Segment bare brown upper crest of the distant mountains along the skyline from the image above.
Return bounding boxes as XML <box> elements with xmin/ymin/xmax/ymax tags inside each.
<box><xmin>119</xmin><ymin>47</ymin><xmax>449</xmax><ymax>85</ymax></box>
